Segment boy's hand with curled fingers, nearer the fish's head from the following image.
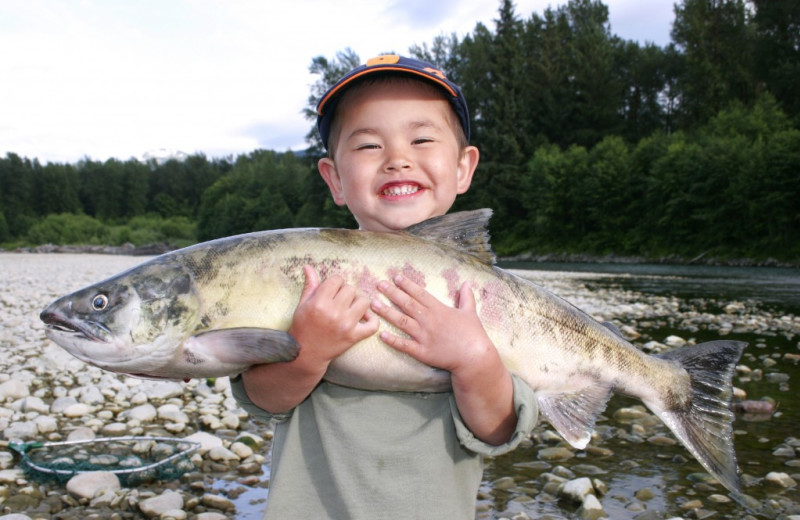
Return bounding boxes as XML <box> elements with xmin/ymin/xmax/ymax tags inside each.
<box><xmin>288</xmin><ymin>265</ymin><xmax>379</xmax><ymax>365</ymax></box>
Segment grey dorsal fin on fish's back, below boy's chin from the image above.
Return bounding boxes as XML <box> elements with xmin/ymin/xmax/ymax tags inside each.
<box><xmin>405</xmin><ymin>208</ymin><xmax>496</xmax><ymax>265</ymax></box>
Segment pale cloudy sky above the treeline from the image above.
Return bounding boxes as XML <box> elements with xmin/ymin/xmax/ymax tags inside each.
<box><xmin>0</xmin><ymin>0</ymin><xmax>676</xmax><ymax>164</ymax></box>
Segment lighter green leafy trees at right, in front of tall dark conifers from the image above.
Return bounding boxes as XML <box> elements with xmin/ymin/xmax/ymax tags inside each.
<box><xmin>510</xmin><ymin>93</ymin><xmax>800</xmax><ymax>261</ymax></box>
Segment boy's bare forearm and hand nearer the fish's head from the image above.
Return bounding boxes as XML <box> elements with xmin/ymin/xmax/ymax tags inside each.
<box><xmin>242</xmin><ymin>266</ymin><xmax>378</xmax><ymax>414</ymax></box>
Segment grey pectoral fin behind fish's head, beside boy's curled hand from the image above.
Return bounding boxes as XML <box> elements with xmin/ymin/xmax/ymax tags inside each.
<box><xmin>193</xmin><ymin>327</ymin><xmax>300</xmax><ymax>365</ymax></box>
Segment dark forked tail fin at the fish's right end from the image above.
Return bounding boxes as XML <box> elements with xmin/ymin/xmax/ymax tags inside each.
<box><xmin>647</xmin><ymin>340</ymin><xmax>747</xmax><ymax>499</ymax></box>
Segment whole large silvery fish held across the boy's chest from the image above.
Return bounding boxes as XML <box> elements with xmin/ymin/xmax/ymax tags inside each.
<box><xmin>41</xmin><ymin>210</ymin><xmax>746</xmax><ymax>493</ymax></box>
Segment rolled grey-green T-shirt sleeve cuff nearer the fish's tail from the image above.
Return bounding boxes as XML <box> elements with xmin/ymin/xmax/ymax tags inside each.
<box><xmin>450</xmin><ymin>374</ymin><xmax>539</xmax><ymax>456</ymax></box>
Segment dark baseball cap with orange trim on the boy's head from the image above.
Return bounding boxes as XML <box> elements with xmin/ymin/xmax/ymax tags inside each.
<box><xmin>317</xmin><ymin>54</ymin><xmax>470</xmax><ymax>148</ymax></box>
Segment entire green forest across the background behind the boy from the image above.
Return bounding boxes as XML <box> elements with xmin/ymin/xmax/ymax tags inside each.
<box><xmin>0</xmin><ymin>0</ymin><xmax>800</xmax><ymax>265</ymax></box>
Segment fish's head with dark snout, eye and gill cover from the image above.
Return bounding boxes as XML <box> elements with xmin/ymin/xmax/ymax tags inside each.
<box><xmin>39</xmin><ymin>263</ymin><xmax>199</xmax><ymax>374</ymax></box>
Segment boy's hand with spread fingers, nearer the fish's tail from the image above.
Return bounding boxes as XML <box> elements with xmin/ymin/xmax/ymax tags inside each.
<box><xmin>372</xmin><ymin>276</ymin><xmax>496</xmax><ymax>373</ymax></box>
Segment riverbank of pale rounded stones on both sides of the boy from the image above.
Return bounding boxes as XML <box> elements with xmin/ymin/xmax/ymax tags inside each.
<box><xmin>0</xmin><ymin>253</ymin><xmax>800</xmax><ymax>520</ymax></box>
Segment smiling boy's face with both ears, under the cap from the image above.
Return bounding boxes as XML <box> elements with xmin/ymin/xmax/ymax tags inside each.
<box><xmin>319</xmin><ymin>81</ymin><xmax>479</xmax><ymax>231</ymax></box>
